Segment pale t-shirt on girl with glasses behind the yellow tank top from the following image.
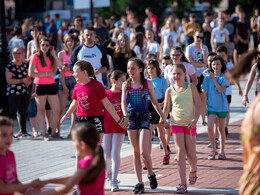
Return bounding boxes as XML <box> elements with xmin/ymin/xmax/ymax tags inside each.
<box><xmin>164</xmin><ymin>62</ymin><xmax>195</xmax><ymax>85</ymax></box>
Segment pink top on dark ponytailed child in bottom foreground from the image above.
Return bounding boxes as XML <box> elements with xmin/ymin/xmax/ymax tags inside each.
<box><xmin>78</xmin><ymin>155</ymin><xmax>105</xmax><ymax>195</ymax></box>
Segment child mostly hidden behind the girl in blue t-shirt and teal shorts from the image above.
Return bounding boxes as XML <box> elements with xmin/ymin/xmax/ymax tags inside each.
<box><xmin>217</xmin><ymin>46</ymin><xmax>243</xmax><ymax>136</ymax></box>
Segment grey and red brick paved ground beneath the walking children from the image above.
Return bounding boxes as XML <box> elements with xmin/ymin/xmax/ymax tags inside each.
<box><xmin>11</xmin><ymin>81</ymin><xmax>253</xmax><ymax>194</ymax></box>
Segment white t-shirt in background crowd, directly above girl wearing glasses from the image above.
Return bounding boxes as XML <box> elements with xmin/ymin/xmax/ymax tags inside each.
<box><xmin>162</xmin><ymin>29</ymin><xmax>180</xmax><ymax>50</ymax></box>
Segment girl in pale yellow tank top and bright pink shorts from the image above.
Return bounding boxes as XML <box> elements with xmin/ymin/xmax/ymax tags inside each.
<box><xmin>163</xmin><ymin>63</ymin><xmax>201</xmax><ymax>193</ymax></box>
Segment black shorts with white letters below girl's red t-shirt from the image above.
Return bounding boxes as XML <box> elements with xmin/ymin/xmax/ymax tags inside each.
<box><xmin>76</xmin><ymin>116</ymin><xmax>105</xmax><ymax>133</ymax></box>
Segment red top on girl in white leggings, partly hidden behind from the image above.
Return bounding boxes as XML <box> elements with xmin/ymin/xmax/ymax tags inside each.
<box><xmin>104</xmin><ymin>90</ymin><xmax>126</xmax><ymax>134</ymax></box>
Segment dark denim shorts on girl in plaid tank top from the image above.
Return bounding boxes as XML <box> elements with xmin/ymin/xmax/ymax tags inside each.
<box><xmin>127</xmin><ymin>112</ymin><xmax>150</xmax><ymax>130</ymax></box>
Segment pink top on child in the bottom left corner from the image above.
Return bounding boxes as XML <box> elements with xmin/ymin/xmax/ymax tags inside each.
<box><xmin>0</xmin><ymin>150</ymin><xmax>18</xmax><ymax>195</ymax></box>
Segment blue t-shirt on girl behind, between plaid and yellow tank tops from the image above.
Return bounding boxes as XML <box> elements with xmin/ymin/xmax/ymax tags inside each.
<box><xmin>147</xmin><ymin>77</ymin><xmax>168</xmax><ymax>100</ymax></box>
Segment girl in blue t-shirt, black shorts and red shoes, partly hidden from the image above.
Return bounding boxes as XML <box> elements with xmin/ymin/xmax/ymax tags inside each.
<box><xmin>147</xmin><ymin>60</ymin><xmax>170</xmax><ymax>165</ymax></box>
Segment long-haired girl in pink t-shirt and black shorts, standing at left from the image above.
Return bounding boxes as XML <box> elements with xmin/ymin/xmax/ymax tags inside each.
<box><xmin>28</xmin><ymin>38</ymin><xmax>62</xmax><ymax>141</ymax></box>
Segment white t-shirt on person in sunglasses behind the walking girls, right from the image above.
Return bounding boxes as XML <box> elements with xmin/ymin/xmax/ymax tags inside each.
<box><xmin>186</xmin><ymin>44</ymin><xmax>209</xmax><ymax>77</ymax></box>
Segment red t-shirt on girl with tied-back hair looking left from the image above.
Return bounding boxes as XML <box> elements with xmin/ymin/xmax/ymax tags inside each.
<box><xmin>72</xmin><ymin>79</ymin><xmax>107</xmax><ymax>116</ymax></box>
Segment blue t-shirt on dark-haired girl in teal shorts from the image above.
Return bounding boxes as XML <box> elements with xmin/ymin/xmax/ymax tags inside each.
<box><xmin>202</xmin><ymin>73</ymin><xmax>229</xmax><ymax>112</ymax></box>
